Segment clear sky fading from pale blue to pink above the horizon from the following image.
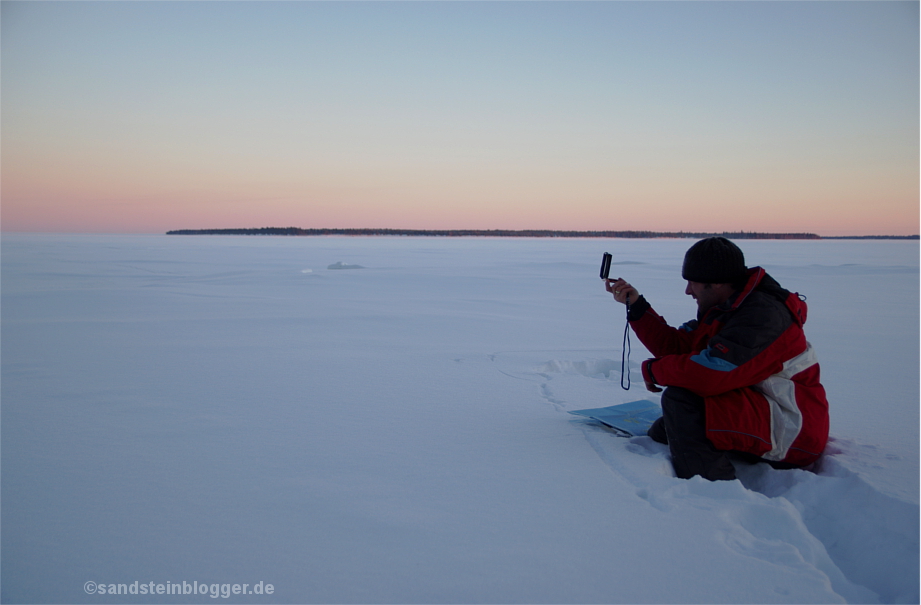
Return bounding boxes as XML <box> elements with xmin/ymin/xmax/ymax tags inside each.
<box><xmin>0</xmin><ymin>0</ymin><xmax>921</xmax><ymax>235</ymax></box>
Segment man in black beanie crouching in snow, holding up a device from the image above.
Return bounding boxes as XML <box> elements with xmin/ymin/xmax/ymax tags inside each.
<box><xmin>605</xmin><ymin>237</ymin><xmax>828</xmax><ymax>480</ymax></box>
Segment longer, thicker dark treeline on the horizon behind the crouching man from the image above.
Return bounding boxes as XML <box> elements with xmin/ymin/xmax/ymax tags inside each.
<box><xmin>166</xmin><ymin>227</ymin><xmax>832</xmax><ymax>239</ymax></box>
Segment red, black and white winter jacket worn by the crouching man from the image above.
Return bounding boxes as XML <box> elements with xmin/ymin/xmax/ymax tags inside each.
<box><xmin>630</xmin><ymin>267</ymin><xmax>828</xmax><ymax>466</ymax></box>
